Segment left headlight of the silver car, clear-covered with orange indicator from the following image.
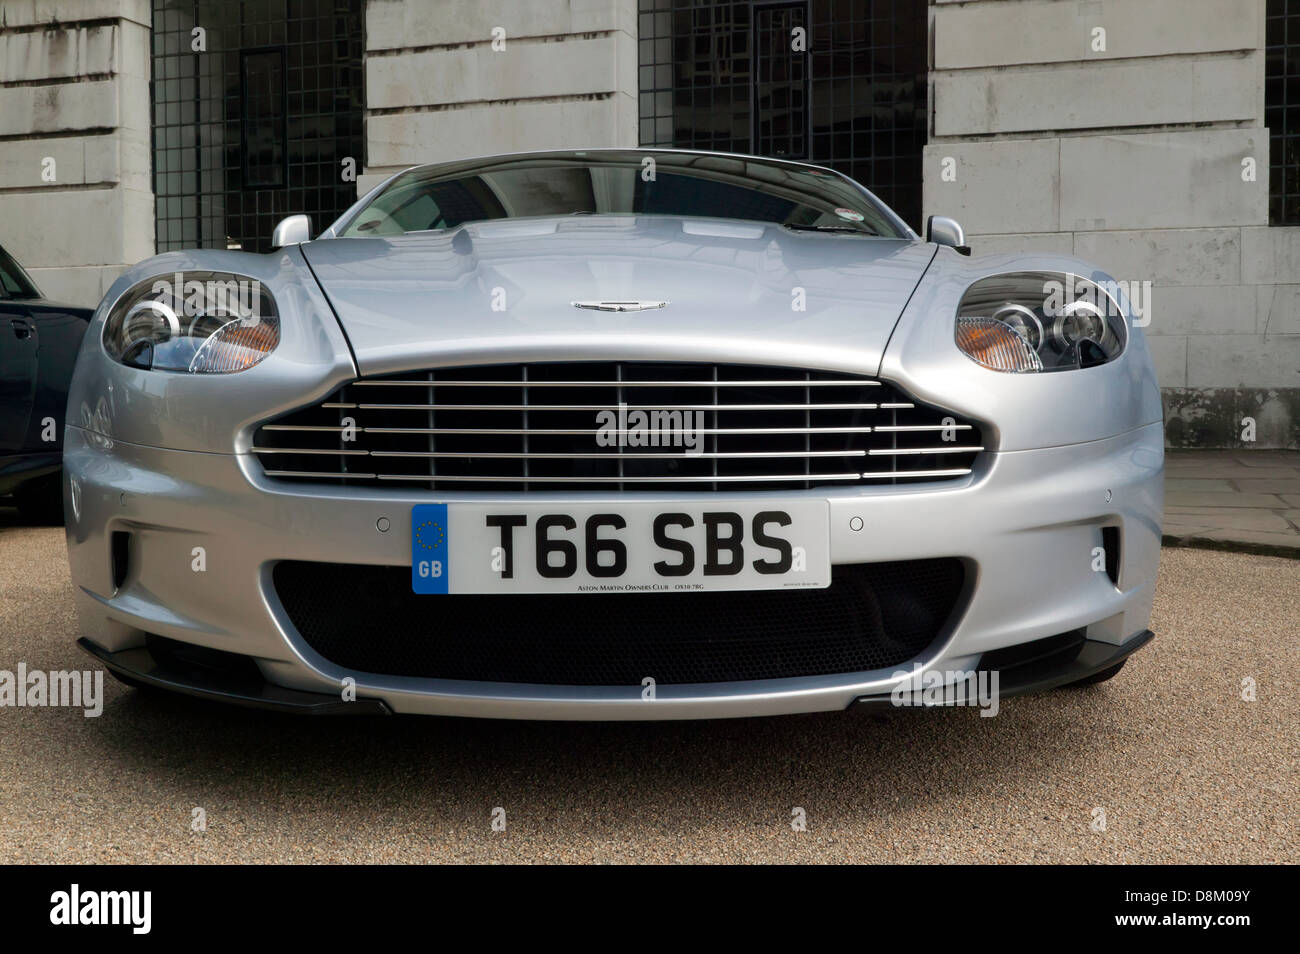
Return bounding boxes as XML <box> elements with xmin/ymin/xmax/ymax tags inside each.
<box><xmin>103</xmin><ymin>272</ymin><xmax>280</xmax><ymax>374</ymax></box>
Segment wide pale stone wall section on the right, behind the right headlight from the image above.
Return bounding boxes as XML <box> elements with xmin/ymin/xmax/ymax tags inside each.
<box><xmin>924</xmin><ymin>0</ymin><xmax>1300</xmax><ymax>447</ymax></box>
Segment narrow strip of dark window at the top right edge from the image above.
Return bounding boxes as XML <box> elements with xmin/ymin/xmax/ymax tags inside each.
<box><xmin>1264</xmin><ymin>0</ymin><xmax>1300</xmax><ymax>225</ymax></box>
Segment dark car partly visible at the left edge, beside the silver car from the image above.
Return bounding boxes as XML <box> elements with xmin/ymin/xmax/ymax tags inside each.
<box><xmin>0</xmin><ymin>248</ymin><xmax>94</xmax><ymax>524</ymax></box>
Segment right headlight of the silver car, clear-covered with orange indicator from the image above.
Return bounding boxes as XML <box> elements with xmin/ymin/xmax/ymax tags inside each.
<box><xmin>957</xmin><ymin>272</ymin><xmax>1127</xmax><ymax>373</ymax></box>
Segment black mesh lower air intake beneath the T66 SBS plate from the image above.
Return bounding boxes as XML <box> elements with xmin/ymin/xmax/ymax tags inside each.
<box><xmin>273</xmin><ymin>559</ymin><xmax>965</xmax><ymax>686</ymax></box>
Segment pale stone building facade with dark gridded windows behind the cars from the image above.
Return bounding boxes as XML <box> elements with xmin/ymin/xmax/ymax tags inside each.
<box><xmin>0</xmin><ymin>0</ymin><xmax>1300</xmax><ymax>447</ymax></box>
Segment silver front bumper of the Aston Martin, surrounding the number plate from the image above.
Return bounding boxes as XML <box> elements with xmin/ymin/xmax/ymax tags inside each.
<box><xmin>65</xmin><ymin>424</ymin><xmax>1164</xmax><ymax>719</ymax></box>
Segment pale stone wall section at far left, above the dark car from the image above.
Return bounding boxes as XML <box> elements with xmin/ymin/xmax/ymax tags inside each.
<box><xmin>0</xmin><ymin>0</ymin><xmax>153</xmax><ymax>305</ymax></box>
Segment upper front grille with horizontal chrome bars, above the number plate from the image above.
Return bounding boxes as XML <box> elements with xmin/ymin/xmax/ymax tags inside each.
<box><xmin>252</xmin><ymin>361</ymin><xmax>984</xmax><ymax>491</ymax></box>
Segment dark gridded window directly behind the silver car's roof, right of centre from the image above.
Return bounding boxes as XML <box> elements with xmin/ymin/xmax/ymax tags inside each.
<box><xmin>637</xmin><ymin>0</ymin><xmax>925</xmax><ymax>229</ymax></box>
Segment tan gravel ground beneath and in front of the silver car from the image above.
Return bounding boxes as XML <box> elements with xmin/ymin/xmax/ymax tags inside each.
<box><xmin>0</xmin><ymin>509</ymin><xmax>1300</xmax><ymax>863</ymax></box>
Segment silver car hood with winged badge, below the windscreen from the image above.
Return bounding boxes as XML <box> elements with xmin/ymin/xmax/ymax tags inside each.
<box><xmin>302</xmin><ymin>216</ymin><xmax>936</xmax><ymax>374</ymax></box>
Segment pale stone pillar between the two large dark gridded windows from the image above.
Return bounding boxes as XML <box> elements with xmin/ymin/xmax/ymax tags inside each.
<box><xmin>358</xmin><ymin>0</ymin><xmax>637</xmax><ymax>192</ymax></box>
